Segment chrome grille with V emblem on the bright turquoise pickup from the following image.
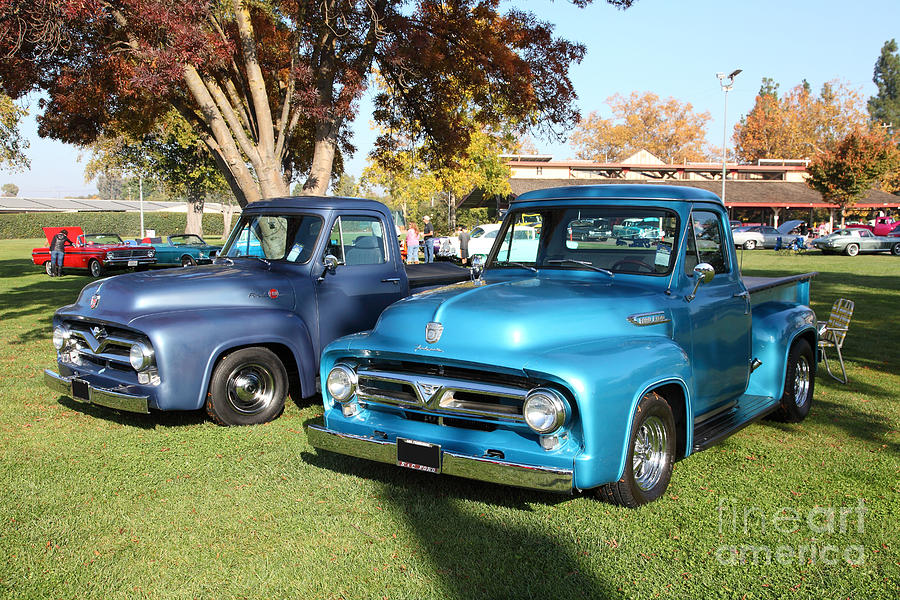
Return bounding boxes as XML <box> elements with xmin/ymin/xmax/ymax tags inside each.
<box><xmin>357</xmin><ymin>366</ymin><xmax>535</xmax><ymax>422</ymax></box>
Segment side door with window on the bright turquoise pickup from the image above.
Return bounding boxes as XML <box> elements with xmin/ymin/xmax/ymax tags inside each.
<box><xmin>684</xmin><ymin>209</ymin><xmax>751</xmax><ymax>415</ymax></box>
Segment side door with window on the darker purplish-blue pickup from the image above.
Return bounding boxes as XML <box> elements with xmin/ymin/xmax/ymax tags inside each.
<box><xmin>316</xmin><ymin>215</ymin><xmax>409</xmax><ymax>351</ymax></box>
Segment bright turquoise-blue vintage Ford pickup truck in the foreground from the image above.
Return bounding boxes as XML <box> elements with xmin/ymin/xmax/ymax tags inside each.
<box><xmin>307</xmin><ymin>185</ymin><xmax>817</xmax><ymax>507</ymax></box>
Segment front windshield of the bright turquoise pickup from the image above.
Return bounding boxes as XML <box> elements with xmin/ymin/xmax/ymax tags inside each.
<box><xmin>487</xmin><ymin>206</ymin><xmax>678</xmax><ymax>275</ymax></box>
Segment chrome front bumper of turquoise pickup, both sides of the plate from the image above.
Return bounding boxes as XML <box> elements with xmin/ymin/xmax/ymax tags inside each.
<box><xmin>306</xmin><ymin>425</ymin><xmax>574</xmax><ymax>493</ymax></box>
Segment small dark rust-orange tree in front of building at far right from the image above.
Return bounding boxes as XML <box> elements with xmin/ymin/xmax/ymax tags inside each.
<box><xmin>806</xmin><ymin>129</ymin><xmax>900</xmax><ymax>227</ymax></box>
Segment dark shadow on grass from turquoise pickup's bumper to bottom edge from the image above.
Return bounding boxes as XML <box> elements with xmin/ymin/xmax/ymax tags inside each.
<box><xmin>301</xmin><ymin>417</ymin><xmax>620</xmax><ymax>599</ymax></box>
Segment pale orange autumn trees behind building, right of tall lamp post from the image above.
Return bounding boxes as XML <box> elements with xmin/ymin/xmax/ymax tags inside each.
<box><xmin>733</xmin><ymin>78</ymin><xmax>868</xmax><ymax>163</ymax></box>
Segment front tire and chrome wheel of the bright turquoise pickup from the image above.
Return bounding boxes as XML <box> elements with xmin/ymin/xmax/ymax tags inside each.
<box><xmin>596</xmin><ymin>392</ymin><xmax>677</xmax><ymax>508</ymax></box>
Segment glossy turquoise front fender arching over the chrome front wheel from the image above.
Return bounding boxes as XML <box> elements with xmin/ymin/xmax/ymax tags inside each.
<box><xmin>525</xmin><ymin>336</ymin><xmax>693</xmax><ymax>489</ymax></box>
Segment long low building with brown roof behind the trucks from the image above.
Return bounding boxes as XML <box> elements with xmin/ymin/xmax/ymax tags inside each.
<box><xmin>457</xmin><ymin>150</ymin><xmax>900</xmax><ymax>228</ymax></box>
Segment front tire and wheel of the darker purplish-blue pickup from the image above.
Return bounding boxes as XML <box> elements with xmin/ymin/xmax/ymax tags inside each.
<box><xmin>206</xmin><ymin>346</ymin><xmax>288</xmax><ymax>425</ymax></box>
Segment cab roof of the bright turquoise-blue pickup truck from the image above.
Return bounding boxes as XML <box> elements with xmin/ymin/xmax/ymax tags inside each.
<box><xmin>511</xmin><ymin>183</ymin><xmax>722</xmax><ymax>204</ymax></box>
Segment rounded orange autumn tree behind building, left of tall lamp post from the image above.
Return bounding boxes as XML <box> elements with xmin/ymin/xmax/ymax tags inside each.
<box><xmin>572</xmin><ymin>92</ymin><xmax>711</xmax><ymax>163</ymax></box>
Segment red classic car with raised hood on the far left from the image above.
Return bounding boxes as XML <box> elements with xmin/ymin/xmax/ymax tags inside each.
<box><xmin>31</xmin><ymin>227</ymin><xmax>156</xmax><ymax>277</ymax></box>
